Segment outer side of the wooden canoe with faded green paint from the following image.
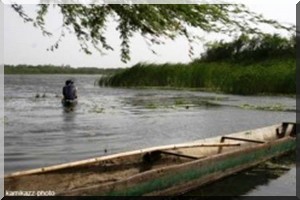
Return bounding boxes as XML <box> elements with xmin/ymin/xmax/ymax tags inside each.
<box><xmin>63</xmin><ymin>136</ymin><xmax>296</xmax><ymax>196</ymax></box>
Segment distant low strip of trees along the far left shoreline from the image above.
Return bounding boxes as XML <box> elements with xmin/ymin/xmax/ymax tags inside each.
<box><xmin>4</xmin><ymin>65</ymin><xmax>122</xmax><ymax>75</ymax></box>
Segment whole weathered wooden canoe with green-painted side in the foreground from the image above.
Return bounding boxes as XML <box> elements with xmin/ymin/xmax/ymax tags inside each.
<box><xmin>4</xmin><ymin>123</ymin><xmax>296</xmax><ymax>196</ymax></box>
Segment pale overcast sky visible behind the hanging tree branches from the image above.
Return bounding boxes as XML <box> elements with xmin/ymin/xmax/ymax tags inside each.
<box><xmin>4</xmin><ymin>0</ymin><xmax>297</xmax><ymax>68</ymax></box>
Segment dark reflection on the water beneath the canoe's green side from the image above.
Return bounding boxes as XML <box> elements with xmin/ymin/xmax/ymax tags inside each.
<box><xmin>184</xmin><ymin>152</ymin><xmax>296</xmax><ymax>196</ymax></box>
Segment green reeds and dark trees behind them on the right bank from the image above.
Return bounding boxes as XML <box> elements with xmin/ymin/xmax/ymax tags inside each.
<box><xmin>99</xmin><ymin>35</ymin><xmax>296</xmax><ymax>95</ymax></box>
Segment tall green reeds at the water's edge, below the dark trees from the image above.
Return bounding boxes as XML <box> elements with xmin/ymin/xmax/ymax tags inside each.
<box><xmin>99</xmin><ymin>58</ymin><xmax>296</xmax><ymax>95</ymax></box>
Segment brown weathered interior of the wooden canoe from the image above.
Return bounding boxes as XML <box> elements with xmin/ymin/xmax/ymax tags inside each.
<box><xmin>4</xmin><ymin>124</ymin><xmax>295</xmax><ymax>194</ymax></box>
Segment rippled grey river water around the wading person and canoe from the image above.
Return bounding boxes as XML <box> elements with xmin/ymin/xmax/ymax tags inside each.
<box><xmin>4</xmin><ymin>75</ymin><xmax>296</xmax><ymax>196</ymax></box>
